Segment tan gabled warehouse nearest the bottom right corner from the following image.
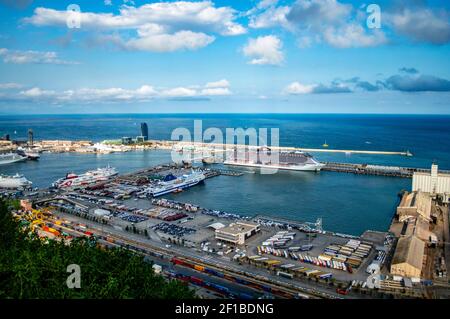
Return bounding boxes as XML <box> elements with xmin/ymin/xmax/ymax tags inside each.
<box><xmin>391</xmin><ymin>235</ymin><xmax>425</xmax><ymax>278</ymax></box>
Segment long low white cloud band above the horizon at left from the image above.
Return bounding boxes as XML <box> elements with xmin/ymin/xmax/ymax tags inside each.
<box><xmin>0</xmin><ymin>79</ymin><xmax>232</xmax><ymax>103</ymax></box>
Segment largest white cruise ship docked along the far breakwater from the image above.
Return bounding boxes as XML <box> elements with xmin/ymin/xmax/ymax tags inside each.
<box><xmin>224</xmin><ymin>149</ymin><xmax>325</xmax><ymax>172</ymax></box>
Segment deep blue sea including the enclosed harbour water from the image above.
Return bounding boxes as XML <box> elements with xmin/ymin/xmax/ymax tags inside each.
<box><xmin>0</xmin><ymin>114</ymin><xmax>450</xmax><ymax>235</ymax></box>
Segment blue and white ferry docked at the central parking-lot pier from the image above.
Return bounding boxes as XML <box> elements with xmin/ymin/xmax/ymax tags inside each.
<box><xmin>147</xmin><ymin>172</ymin><xmax>206</xmax><ymax>197</ymax></box>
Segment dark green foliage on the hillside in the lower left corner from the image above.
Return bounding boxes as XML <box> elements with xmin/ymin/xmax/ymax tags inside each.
<box><xmin>0</xmin><ymin>202</ymin><xmax>194</xmax><ymax>299</ymax></box>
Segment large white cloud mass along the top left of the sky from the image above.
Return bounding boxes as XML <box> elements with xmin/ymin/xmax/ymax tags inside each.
<box><xmin>24</xmin><ymin>1</ymin><xmax>246</xmax><ymax>52</ymax></box>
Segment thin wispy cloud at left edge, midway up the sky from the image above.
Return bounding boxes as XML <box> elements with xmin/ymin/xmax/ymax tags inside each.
<box><xmin>0</xmin><ymin>48</ymin><xmax>79</xmax><ymax>65</ymax></box>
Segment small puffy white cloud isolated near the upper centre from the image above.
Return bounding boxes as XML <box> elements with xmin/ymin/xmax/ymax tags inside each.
<box><xmin>243</xmin><ymin>35</ymin><xmax>284</xmax><ymax>65</ymax></box>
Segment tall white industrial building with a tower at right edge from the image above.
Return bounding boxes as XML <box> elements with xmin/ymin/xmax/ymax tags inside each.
<box><xmin>412</xmin><ymin>164</ymin><xmax>450</xmax><ymax>203</ymax></box>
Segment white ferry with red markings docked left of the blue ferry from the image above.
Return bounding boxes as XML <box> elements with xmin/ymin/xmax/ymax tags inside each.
<box><xmin>53</xmin><ymin>166</ymin><xmax>118</xmax><ymax>188</ymax></box>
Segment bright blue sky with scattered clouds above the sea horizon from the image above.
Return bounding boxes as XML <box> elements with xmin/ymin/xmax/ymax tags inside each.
<box><xmin>0</xmin><ymin>0</ymin><xmax>450</xmax><ymax>114</ymax></box>
